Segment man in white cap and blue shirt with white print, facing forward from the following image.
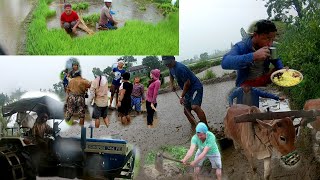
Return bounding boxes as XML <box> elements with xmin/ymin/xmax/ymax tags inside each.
<box><xmin>109</xmin><ymin>59</ymin><xmax>126</xmax><ymax>108</ymax></box>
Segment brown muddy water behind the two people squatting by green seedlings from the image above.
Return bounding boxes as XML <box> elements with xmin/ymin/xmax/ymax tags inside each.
<box><xmin>48</xmin><ymin>0</ymin><xmax>164</xmax><ymax>33</ymax></box>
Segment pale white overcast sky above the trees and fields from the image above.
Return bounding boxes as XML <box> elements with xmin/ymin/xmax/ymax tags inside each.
<box><xmin>0</xmin><ymin>0</ymin><xmax>267</xmax><ymax>93</ymax></box>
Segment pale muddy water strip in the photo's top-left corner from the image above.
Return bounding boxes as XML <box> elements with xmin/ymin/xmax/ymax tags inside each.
<box><xmin>0</xmin><ymin>0</ymin><xmax>32</xmax><ymax>55</ymax></box>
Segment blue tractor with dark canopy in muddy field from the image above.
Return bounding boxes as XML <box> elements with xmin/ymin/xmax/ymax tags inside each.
<box><xmin>0</xmin><ymin>96</ymin><xmax>136</xmax><ymax>179</ymax></box>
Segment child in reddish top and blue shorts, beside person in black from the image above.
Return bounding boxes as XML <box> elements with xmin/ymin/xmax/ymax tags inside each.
<box><xmin>131</xmin><ymin>77</ymin><xmax>145</xmax><ymax>115</ymax></box>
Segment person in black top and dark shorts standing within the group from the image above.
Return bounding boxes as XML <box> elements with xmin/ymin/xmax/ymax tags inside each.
<box><xmin>117</xmin><ymin>72</ymin><xmax>133</xmax><ymax>125</ymax></box>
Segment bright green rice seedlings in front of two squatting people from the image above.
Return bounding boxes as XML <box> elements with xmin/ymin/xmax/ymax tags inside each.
<box><xmin>26</xmin><ymin>0</ymin><xmax>179</xmax><ymax>55</ymax></box>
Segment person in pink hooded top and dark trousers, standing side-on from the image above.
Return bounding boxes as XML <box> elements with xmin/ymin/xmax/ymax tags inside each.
<box><xmin>146</xmin><ymin>69</ymin><xmax>161</xmax><ymax>128</ymax></box>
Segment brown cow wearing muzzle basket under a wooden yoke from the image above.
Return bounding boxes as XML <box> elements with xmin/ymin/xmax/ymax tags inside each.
<box><xmin>224</xmin><ymin>104</ymin><xmax>300</xmax><ymax>179</ymax></box>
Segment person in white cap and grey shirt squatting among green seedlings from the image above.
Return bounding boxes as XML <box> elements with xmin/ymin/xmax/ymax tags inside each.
<box><xmin>99</xmin><ymin>0</ymin><xmax>118</xmax><ymax>30</ymax></box>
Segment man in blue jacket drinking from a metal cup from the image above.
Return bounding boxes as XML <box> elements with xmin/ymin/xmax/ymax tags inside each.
<box><xmin>221</xmin><ymin>20</ymin><xmax>283</xmax><ymax>87</ymax></box>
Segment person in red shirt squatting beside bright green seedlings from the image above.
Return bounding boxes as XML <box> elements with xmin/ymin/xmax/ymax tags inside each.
<box><xmin>60</xmin><ymin>3</ymin><xmax>80</xmax><ymax>34</ymax></box>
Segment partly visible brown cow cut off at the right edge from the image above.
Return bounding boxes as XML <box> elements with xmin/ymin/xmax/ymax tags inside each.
<box><xmin>301</xmin><ymin>99</ymin><xmax>320</xmax><ymax>131</ymax></box>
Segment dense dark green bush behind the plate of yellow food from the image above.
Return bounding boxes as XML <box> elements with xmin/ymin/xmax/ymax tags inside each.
<box><xmin>278</xmin><ymin>10</ymin><xmax>320</xmax><ymax>109</ymax></box>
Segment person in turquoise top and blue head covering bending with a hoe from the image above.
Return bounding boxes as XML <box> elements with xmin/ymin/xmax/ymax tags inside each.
<box><xmin>181</xmin><ymin>122</ymin><xmax>222</xmax><ymax>180</ymax></box>
